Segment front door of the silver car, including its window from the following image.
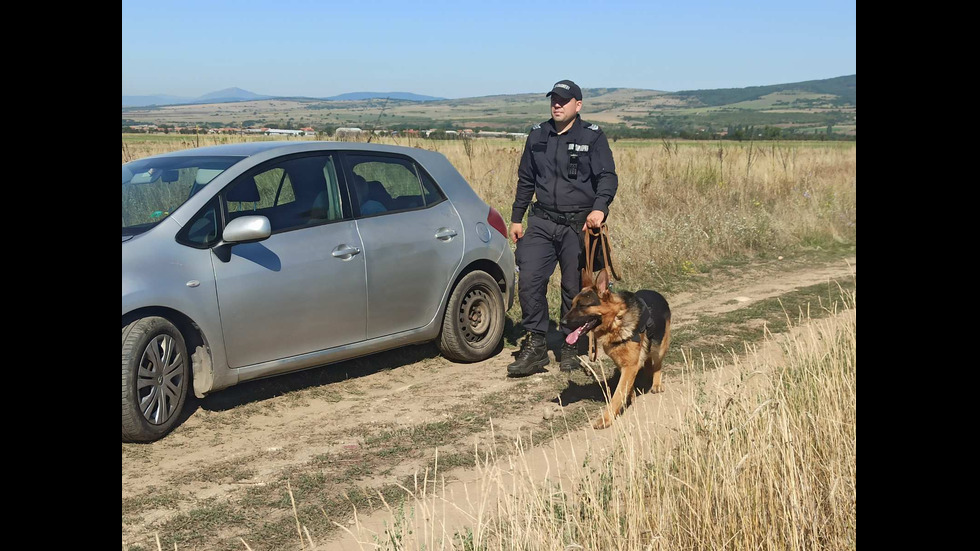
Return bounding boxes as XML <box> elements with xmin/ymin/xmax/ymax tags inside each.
<box><xmin>214</xmin><ymin>153</ymin><xmax>367</xmax><ymax>367</ymax></box>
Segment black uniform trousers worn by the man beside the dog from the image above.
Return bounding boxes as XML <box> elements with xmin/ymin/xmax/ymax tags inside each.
<box><xmin>515</xmin><ymin>214</ymin><xmax>585</xmax><ymax>335</ymax></box>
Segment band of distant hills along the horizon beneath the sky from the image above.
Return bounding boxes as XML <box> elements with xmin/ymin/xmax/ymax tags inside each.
<box><xmin>122</xmin><ymin>75</ymin><xmax>857</xmax><ymax>139</ymax></box>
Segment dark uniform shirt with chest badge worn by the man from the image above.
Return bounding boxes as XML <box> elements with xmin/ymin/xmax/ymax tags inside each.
<box><xmin>510</xmin><ymin>115</ymin><xmax>619</xmax><ymax>222</ymax></box>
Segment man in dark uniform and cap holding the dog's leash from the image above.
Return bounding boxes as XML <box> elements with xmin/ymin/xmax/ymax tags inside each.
<box><xmin>507</xmin><ymin>80</ymin><xmax>619</xmax><ymax>377</ymax></box>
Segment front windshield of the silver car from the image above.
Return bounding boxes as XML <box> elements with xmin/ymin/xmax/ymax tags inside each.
<box><xmin>122</xmin><ymin>156</ymin><xmax>243</xmax><ymax>236</ymax></box>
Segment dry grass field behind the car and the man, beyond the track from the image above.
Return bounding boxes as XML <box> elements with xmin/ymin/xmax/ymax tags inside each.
<box><xmin>123</xmin><ymin>135</ymin><xmax>857</xmax><ymax>288</ymax></box>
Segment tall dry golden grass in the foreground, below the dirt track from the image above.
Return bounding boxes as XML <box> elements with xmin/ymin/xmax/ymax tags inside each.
<box><xmin>338</xmin><ymin>295</ymin><xmax>857</xmax><ymax>550</ymax></box>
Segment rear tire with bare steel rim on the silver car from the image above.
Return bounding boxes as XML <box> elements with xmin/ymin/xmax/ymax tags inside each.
<box><xmin>439</xmin><ymin>271</ymin><xmax>506</xmax><ymax>362</ymax></box>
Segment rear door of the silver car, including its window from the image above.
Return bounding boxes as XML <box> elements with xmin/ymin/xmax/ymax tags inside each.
<box><xmin>344</xmin><ymin>153</ymin><xmax>463</xmax><ymax>338</ymax></box>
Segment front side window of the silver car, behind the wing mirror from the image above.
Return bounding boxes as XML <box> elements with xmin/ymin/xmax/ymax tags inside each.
<box><xmin>222</xmin><ymin>154</ymin><xmax>343</xmax><ymax>233</ymax></box>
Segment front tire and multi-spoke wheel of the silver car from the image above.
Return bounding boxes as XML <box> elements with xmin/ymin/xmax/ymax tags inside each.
<box><xmin>122</xmin><ymin>316</ymin><xmax>190</xmax><ymax>442</ymax></box>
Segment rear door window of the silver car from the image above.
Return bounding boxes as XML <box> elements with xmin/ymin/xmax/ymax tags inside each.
<box><xmin>348</xmin><ymin>154</ymin><xmax>426</xmax><ymax>217</ymax></box>
